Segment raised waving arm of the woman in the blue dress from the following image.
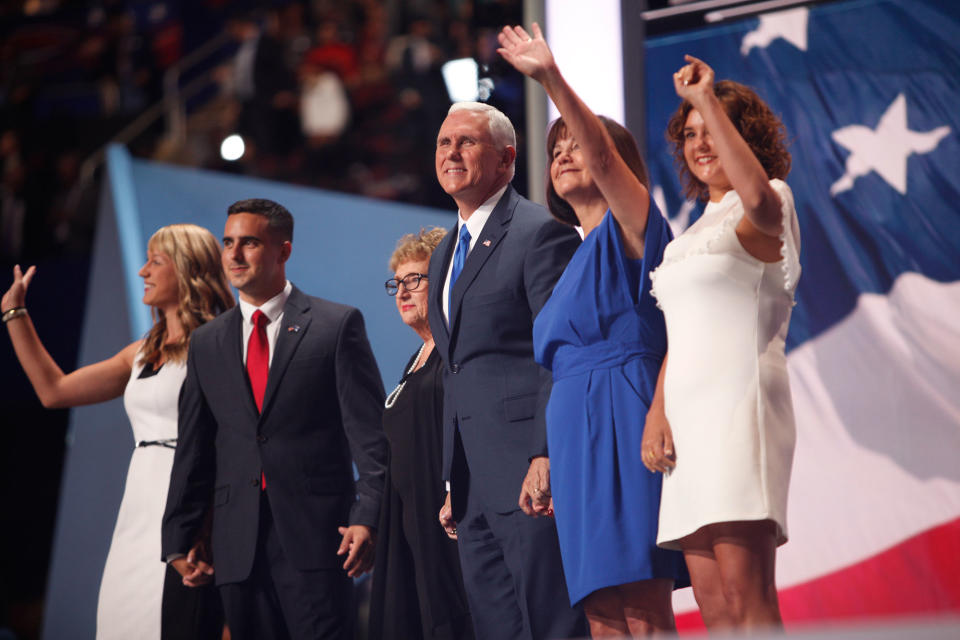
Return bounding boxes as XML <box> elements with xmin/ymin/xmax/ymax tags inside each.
<box><xmin>497</xmin><ymin>23</ymin><xmax>650</xmax><ymax>248</ymax></box>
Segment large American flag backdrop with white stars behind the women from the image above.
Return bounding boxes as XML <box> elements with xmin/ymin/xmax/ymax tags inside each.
<box><xmin>646</xmin><ymin>0</ymin><xmax>960</xmax><ymax>628</ymax></box>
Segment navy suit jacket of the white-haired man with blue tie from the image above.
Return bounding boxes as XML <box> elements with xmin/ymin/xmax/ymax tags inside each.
<box><xmin>429</xmin><ymin>187</ymin><xmax>580</xmax><ymax>518</ymax></box>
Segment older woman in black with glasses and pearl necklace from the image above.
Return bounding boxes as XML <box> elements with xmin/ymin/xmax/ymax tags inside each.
<box><xmin>369</xmin><ymin>228</ymin><xmax>473</xmax><ymax>639</ymax></box>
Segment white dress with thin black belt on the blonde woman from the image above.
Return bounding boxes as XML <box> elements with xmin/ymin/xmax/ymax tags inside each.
<box><xmin>97</xmin><ymin>354</ymin><xmax>187</xmax><ymax>640</ymax></box>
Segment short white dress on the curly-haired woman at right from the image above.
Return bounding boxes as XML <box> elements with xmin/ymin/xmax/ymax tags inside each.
<box><xmin>650</xmin><ymin>180</ymin><xmax>800</xmax><ymax>548</ymax></box>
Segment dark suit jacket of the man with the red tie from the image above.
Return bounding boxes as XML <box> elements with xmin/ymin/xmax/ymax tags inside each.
<box><xmin>162</xmin><ymin>287</ymin><xmax>387</xmax><ymax>584</ymax></box>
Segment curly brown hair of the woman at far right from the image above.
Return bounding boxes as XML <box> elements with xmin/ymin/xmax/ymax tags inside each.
<box><xmin>666</xmin><ymin>80</ymin><xmax>790</xmax><ymax>200</ymax></box>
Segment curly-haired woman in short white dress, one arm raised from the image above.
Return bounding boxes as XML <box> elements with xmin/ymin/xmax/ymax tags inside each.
<box><xmin>642</xmin><ymin>56</ymin><xmax>800</xmax><ymax>629</ymax></box>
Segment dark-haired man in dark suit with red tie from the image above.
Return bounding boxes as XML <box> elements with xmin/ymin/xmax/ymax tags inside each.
<box><xmin>162</xmin><ymin>199</ymin><xmax>387</xmax><ymax>640</ymax></box>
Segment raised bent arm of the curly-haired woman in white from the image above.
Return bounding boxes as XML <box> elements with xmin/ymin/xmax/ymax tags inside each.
<box><xmin>673</xmin><ymin>55</ymin><xmax>783</xmax><ymax>240</ymax></box>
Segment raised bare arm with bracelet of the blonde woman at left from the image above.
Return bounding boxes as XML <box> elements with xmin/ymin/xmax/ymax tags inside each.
<box><xmin>0</xmin><ymin>265</ymin><xmax>140</xmax><ymax>409</ymax></box>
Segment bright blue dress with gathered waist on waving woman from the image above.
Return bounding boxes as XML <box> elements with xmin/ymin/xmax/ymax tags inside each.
<box><xmin>533</xmin><ymin>202</ymin><xmax>689</xmax><ymax>604</ymax></box>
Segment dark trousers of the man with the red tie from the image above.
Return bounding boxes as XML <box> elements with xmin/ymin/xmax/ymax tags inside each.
<box><xmin>220</xmin><ymin>492</ymin><xmax>354</xmax><ymax>640</ymax></box>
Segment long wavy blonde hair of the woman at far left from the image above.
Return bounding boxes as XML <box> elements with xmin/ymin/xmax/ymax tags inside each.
<box><xmin>142</xmin><ymin>224</ymin><xmax>234</xmax><ymax>368</ymax></box>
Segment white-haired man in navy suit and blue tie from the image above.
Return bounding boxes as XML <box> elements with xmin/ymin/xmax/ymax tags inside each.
<box><xmin>429</xmin><ymin>103</ymin><xmax>587</xmax><ymax>640</ymax></box>
